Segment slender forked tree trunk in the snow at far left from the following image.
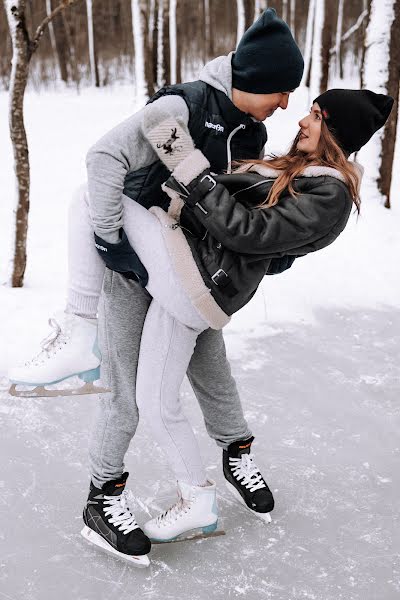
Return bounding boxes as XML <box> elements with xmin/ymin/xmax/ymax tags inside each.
<box><xmin>4</xmin><ymin>0</ymin><xmax>79</xmax><ymax>287</ymax></box>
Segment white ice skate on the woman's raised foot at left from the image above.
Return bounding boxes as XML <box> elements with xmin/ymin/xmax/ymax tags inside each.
<box><xmin>8</xmin><ymin>313</ymin><xmax>108</xmax><ymax>397</ymax></box>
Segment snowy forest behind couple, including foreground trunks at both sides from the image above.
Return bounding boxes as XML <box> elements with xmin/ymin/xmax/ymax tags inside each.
<box><xmin>0</xmin><ymin>0</ymin><xmax>400</xmax><ymax>287</ymax></box>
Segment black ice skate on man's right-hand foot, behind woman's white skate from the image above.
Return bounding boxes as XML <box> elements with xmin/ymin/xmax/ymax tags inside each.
<box><xmin>222</xmin><ymin>437</ymin><xmax>274</xmax><ymax>523</ymax></box>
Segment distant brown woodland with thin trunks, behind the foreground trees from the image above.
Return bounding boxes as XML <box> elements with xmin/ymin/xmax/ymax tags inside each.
<box><xmin>0</xmin><ymin>0</ymin><xmax>396</xmax><ymax>94</ymax></box>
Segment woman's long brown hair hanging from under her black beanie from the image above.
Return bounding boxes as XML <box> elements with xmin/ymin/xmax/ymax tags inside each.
<box><xmin>239</xmin><ymin>121</ymin><xmax>361</xmax><ymax>213</ymax></box>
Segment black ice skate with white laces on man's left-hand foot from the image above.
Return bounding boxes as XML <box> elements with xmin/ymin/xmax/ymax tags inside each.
<box><xmin>81</xmin><ymin>473</ymin><xmax>151</xmax><ymax>567</ymax></box>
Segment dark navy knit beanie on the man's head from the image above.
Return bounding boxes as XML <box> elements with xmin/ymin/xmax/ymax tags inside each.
<box><xmin>232</xmin><ymin>8</ymin><xmax>304</xmax><ymax>94</ymax></box>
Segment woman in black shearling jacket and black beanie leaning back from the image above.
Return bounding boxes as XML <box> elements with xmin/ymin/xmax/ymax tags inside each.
<box><xmin>9</xmin><ymin>90</ymin><xmax>393</xmax><ymax>556</ymax></box>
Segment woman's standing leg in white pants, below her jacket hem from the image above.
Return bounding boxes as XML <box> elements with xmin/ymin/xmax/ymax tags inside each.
<box><xmin>136</xmin><ymin>300</ymin><xmax>206</xmax><ymax>486</ymax></box>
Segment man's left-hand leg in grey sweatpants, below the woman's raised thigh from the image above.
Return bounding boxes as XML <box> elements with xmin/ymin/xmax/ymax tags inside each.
<box><xmin>89</xmin><ymin>269</ymin><xmax>151</xmax><ymax>487</ymax></box>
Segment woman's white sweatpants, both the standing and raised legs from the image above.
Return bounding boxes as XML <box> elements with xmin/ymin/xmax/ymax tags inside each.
<box><xmin>68</xmin><ymin>188</ymin><xmax>208</xmax><ymax>485</ymax></box>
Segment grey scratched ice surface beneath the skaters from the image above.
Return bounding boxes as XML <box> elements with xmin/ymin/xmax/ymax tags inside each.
<box><xmin>0</xmin><ymin>310</ymin><xmax>400</xmax><ymax>600</ymax></box>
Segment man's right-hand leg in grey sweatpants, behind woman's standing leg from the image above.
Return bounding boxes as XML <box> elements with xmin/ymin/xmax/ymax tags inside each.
<box><xmin>187</xmin><ymin>329</ymin><xmax>252</xmax><ymax>449</ymax></box>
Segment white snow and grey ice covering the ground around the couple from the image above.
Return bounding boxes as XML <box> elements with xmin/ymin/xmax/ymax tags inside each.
<box><xmin>0</xmin><ymin>86</ymin><xmax>400</xmax><ymax>600</ymax></box>
